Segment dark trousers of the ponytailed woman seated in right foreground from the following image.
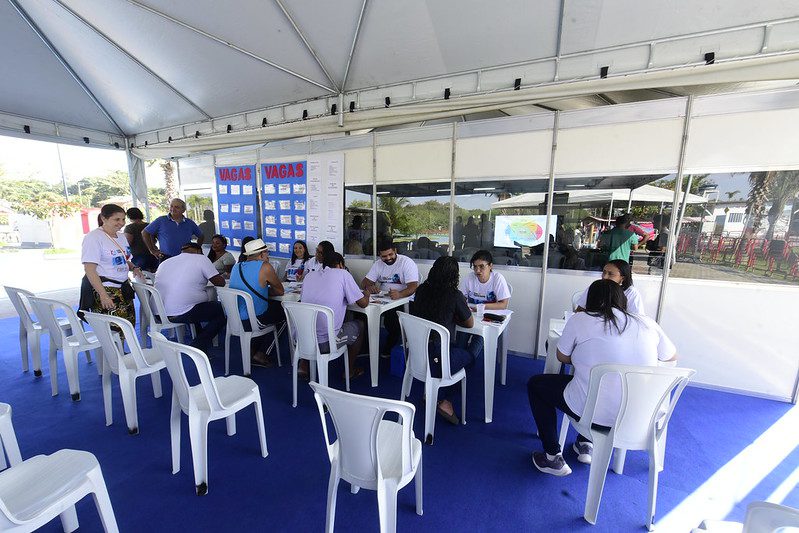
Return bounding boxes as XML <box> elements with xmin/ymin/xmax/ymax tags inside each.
<box><xmin>527</xmin><ymin>374</ymin><xmax>590</xmax><ymax>455</ymax></box>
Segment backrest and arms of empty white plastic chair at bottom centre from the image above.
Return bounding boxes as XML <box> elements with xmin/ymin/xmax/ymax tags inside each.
<box><xmin>310</xmin><ymin>382</ymin><xmax>416</xmax><ymax>482</ymax></box>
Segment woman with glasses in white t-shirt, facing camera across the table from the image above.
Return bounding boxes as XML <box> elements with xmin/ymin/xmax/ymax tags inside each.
<box><xmin>456</xmin><ymin>250</ymin><xmax>511</xmax><ymax>353</ymax></box>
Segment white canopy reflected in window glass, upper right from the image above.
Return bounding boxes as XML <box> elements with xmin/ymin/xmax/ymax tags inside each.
<box><xmin>491</xmin><ymin>185</ymin><xmax>707</xmax><ymax>209</ymax></box>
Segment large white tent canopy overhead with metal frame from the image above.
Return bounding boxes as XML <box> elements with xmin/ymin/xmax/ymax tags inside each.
<box><xmin>0</xmin><ymin>0</ymin><xmax>799</xmax><ymax>158</ymax></box>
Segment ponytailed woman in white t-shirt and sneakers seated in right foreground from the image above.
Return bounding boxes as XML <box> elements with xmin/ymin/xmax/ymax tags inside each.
<box><xmin>527</xmin><ymin>279</ymin><xmax>677</xmax><ymax>476</ymax></box>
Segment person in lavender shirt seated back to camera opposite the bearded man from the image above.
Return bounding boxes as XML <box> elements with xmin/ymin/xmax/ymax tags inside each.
<box><xmin>300</xmin><ymin>252</ymin><xmax>369</xmax><ymax>379</ymax></box>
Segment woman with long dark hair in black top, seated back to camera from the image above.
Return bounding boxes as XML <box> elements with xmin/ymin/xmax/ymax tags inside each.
<box><xmin>411</xmin><ymin>256</ymin><xmax>477</xmax><ymax>424</ymax></box>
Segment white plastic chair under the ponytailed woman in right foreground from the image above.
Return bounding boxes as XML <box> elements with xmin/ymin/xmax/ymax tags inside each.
<box><xmin>561</xmin><ymin>364</ymin><xmax>696</xmax><ymax>531</ymax></box>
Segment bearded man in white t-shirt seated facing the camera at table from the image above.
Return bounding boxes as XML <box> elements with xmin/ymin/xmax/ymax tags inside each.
<box><xmin>361</xmin><ymin>237</ymin><xmax>419</xmax><ymax>353</ymax></box>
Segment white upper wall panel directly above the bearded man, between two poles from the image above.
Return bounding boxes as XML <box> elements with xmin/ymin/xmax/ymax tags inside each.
<box><xmin>377</xmin><ymin>140</ymin><xmax>452</xmax><ymax>183</ymax></box>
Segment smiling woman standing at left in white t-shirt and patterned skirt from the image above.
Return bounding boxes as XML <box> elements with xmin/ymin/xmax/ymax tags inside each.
<box><xmin>79</xmin><ymin>204</ymin><xmax>142</xmax><ymax>325</ymax></box>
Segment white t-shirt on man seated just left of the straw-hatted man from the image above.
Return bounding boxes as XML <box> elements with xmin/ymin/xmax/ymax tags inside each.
<box><xmin>155</xmin><ymin>253</ymin><xmax>219</xmax><ymax>316</ymax></box>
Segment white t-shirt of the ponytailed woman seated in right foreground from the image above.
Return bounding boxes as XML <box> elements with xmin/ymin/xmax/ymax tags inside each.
<box><xmin>558</xmin><ymin>309</ymin><xmax>677</xmax><ymax>426</ymax></box>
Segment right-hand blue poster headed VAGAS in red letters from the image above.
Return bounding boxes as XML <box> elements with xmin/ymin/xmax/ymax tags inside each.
<box><xmin>261</xmin><ymin>161</ymin><xmax>307</xmax><ymax>258</ymax></box>
